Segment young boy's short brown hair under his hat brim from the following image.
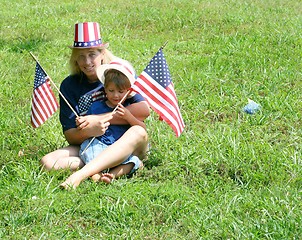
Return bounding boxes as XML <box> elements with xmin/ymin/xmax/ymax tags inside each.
<box><xmin>104</xmin><ymin>69</ymin><xmax>131</xmax><ymax>90</ymax></box>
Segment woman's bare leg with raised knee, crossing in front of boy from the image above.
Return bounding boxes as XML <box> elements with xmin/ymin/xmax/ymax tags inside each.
<box><xmin>61</xmin><ymin>126</ymin><xmax>148</xmax><ymax>188</ymax></box>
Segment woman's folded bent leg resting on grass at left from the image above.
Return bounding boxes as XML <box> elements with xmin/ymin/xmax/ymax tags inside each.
<box><xmin>41</xmin><ymin>145</ymin><xmax>84</xmax><ymax>171</ymax></box>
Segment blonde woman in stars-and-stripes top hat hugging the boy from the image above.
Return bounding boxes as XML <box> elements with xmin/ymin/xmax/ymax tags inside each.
<box><xmin>41</xmin><ymin>22</ymin><xmax>150</xmax><ymax>187</ymax></box>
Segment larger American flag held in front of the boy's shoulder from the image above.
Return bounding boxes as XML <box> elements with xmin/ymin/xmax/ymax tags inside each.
<box><xmin>132</xmin><ymin>49</ymin><xmax>185</xmax><ymax>137</ymax></box>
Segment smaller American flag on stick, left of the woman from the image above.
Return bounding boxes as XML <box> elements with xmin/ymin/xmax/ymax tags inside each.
<box><xmin>31</xmin><ymin>62</ymin><xmax>59</xmax><ymax>128</ymax></box>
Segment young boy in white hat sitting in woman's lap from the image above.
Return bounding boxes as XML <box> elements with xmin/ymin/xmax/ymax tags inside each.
<box><xmin>80</xmin><ymin>59</ymin><xmax>146</xmax><ymax>183</ymax></box>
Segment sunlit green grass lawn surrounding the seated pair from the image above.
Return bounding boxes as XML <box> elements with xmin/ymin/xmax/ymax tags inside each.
<box><xmin>0</xmin><ymin>0</ymin><xmax>302</xmax><ymax>239</ymax></box>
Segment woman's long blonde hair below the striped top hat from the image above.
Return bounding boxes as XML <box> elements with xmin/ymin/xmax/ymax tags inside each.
<box><xmin>69</xmin><ymin>48</ymin><xmax>114</xmax><ymax>75</ymax></box>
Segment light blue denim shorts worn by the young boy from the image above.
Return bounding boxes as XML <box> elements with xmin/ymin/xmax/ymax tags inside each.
<box><xmin>79</xmin><ymin>138</ymin><xmax>141</xmax><ymax>174</ymax></box>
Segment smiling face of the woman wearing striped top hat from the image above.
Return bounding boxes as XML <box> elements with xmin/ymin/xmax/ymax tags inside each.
<box><xmin>77</xmin><ymin>48</ymin><xmax>104</xmax><ymax>82</ymax></box>
